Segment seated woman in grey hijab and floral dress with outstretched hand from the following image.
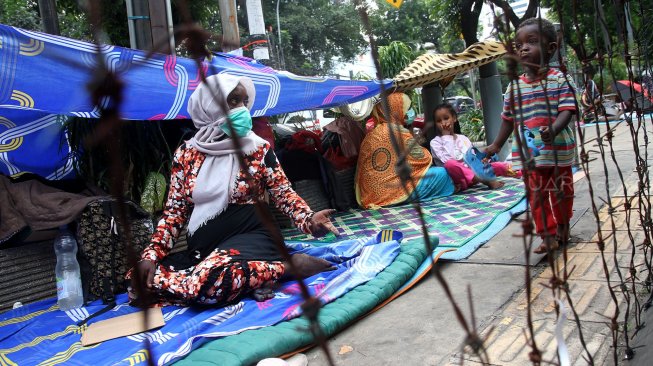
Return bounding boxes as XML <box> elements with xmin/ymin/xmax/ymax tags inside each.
<box><xmin>128</xmin><ymin>74</ymin><xmax>338</xmax><ymax>305</ymax></box>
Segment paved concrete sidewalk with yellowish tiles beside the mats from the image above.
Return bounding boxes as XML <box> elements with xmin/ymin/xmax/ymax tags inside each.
<box><xmin>306</xmin><ymin>118</ymin><xmax>651</xmax><ymax>366</ymax></box>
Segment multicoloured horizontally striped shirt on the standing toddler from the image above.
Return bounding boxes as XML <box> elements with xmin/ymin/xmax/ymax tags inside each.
<box><xmin>501</xmin><ymin>69</ymin><xmax>577</xmax><ymax>170</ymax></box>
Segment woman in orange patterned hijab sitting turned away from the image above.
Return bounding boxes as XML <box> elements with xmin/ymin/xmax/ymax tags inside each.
<box><xmin>355</xmin><ymin>93</ymin><xmax>454</xmax><ymax>209</ymax></box>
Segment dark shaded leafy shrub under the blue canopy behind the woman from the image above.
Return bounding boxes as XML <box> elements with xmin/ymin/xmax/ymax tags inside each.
<box><xmin>65</xmin><ymin>117</ymin><xmax>194</xmax><ymax>214</ymax></box>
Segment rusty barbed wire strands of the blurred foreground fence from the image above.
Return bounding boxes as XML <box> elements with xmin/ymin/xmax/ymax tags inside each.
<box><xmin>74</xmin><ymin>0</ymin><xmax>653</xmax><ymax>364</ymax></box>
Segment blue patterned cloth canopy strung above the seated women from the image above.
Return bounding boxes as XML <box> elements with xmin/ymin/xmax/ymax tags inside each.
<box><xmin>0</xmin><ymin>24</ymin><xmax>392</xmax><ymax>179</ymax></box>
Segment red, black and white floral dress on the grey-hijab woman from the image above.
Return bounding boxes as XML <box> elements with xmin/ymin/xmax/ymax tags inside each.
<box><xmin>128</xmin><ymin>142</ymin><xmax>314</xmax><ymax>305</ymax></box>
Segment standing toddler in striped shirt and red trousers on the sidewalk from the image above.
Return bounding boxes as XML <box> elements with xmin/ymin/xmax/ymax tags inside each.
<box><xmin>485</xmin><ymin>18</ymin><xmax>577</xmax><ymax>253</ymax></box>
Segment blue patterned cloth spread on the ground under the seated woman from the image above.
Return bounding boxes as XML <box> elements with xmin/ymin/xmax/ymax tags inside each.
<box><xmin>0</xmin><ymin>236</ymin><xmax>400</xmax><ymax>365</ymax></box>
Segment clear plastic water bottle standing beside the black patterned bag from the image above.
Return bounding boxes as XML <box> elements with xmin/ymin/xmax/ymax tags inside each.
<box><xmin>54</xmin><ymin>226</ymin><xmax>84</xmax><ymax>311</ymax></box>
